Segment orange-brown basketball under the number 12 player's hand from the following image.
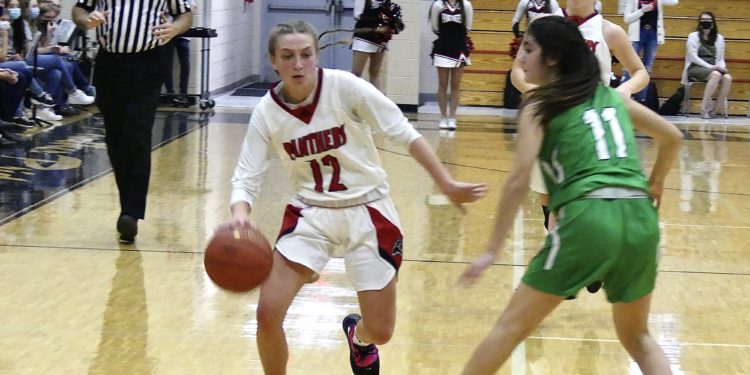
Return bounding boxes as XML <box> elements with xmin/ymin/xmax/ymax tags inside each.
<box><xmin>203</xmin><ymin>226</ymin><xmax>273</xmax><ymax>292</ymax></box>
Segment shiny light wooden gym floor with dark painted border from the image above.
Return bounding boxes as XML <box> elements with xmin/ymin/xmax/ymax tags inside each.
<box><xmin>0</xmin><ymin>109</ymin><xmax>750</xmax><ymax>374</ymax></box>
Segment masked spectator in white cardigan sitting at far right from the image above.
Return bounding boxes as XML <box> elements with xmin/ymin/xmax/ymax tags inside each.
<box><xmin>682</xmin><ymin>11</ymin><xmax>732</xmax><ymax>119</ymax></box>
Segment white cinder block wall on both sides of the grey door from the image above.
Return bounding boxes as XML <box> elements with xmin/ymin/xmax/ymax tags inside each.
<box><xmin>62</xmin><ymin>0</ymin><xmax>428</xmax><ymax>105</ymax></box>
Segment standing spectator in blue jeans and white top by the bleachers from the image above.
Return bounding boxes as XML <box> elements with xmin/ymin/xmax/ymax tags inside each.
<box><xmin>623</xmin><ymin>0</ymin><xmax>680</xmax><ymax>102</ymax></box>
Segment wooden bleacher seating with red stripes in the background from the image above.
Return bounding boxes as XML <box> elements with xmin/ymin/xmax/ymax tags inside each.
<box><xmin>470</xmin><ymin>0</ymin><xmax>750</xmax><ymax>115</ymax></box>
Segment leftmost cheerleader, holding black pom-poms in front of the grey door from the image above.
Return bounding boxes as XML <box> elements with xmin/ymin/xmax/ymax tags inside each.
<box><xmin>351</xmin><ymin>0</ymin><xmax>404</xmax><ymax>89</ymax></box>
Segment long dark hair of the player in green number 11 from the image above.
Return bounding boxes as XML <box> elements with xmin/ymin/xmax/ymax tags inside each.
<box><xmin>519</xmin><ymin>16</ymin><xmax>601</xmax><ymax>127</ymax></box>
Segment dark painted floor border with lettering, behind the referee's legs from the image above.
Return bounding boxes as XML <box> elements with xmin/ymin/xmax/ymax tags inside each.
<box><xmin>0</xmin><ymin>112</ymin><xmax>212</xmax><ymax>225</ymax></box>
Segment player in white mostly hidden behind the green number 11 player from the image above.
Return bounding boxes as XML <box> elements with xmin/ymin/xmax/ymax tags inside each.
<box><xmin>511</xmin><ymin>0</ymin><xmax>649</xmax><ymax>293</ymax></box>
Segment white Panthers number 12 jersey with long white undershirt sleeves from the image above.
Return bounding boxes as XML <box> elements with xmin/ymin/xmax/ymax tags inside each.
<box><xmin>231</xmin><ymin>68</ymin><xmax>421</xmax><ymax>207</ymax></box>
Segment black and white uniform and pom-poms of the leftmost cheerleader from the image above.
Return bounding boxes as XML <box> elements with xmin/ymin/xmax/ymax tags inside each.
<box><xmin>351</xmin><ymin>0</ymin><xmax>404</xmax><ymax>53</ymax></box>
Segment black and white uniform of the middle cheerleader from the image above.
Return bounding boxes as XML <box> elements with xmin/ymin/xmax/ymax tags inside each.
<box><xmin>430</xmin><ymin>0</ymin><xmax>474</xmax><ymax>68</ymax></box>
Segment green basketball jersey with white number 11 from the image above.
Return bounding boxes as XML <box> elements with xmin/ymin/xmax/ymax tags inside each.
<box><xmin>539</xmin><ymin>85</ymin><xmax>648</xmax><ymax>212</ymax></box>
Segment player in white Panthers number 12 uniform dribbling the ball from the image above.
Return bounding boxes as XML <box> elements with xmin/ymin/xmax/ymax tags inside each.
<box><xmin>227</xmin><ymin>21</ymin><xmax>486</xmax><ymax>375</ymax></box>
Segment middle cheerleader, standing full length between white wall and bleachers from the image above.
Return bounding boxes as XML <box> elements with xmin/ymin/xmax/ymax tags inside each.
<box><xmin>430</xmin><ymin>0</ymin><xmax>474</xmax><ymax>130</ymax></box>
